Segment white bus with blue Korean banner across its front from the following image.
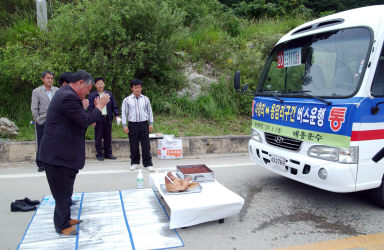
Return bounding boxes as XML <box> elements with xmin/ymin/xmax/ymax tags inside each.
<box><xmin>235</xmin><ymin>5</ymin><xmax>384</xmax><ymax>208</ymax></box>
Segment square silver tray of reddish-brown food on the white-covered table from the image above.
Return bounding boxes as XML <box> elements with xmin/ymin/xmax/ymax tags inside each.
<box><xmin>176</xmin><ymin>164</ymin><xmax>214</xmax><ymax>182</ymax></box>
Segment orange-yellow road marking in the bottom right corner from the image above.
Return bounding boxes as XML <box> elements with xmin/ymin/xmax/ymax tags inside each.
<box><xmin>275</xmin><ymin>233</ymin><xmax>384</xmax><ymax>250</ymax></box>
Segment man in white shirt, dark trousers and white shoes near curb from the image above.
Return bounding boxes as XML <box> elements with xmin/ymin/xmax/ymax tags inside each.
<box><xmin>121</xmin><ymin>79</ymin><xmax>154</xmax><ymax>172</ymax></box>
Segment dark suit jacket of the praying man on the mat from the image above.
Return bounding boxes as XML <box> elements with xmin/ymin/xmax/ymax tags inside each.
<box><xmin>39</xmin><ymin>85</ymin><xmax>101</xmax><ymax>169</ymax></box>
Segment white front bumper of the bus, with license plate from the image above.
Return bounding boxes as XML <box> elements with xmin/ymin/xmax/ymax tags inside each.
<box><xmin>248</xmin><ymin>139</ymin><xmax>357</xmax><ymax>193</ymax></box>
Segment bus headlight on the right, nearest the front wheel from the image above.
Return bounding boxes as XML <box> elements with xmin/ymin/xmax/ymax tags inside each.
<box><xmin>308</xmin><ymin>145</ymin><xmax>358</xmax><ymax>164</ymax></box>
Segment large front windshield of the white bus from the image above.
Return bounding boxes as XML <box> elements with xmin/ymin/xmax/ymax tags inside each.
<box><xmin>258</xmin><ymin>27</ymin><xmax>371</xmax><ymax>98</ymax></box>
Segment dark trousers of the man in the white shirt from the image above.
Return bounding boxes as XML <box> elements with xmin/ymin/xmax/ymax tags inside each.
<box><xmin>128</xmin><ymin>121</ymin><xmax>152</xmax><ymax>167</ymax></box>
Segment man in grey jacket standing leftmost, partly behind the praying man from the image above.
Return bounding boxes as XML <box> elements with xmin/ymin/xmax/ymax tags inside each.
<box><xmin>31</xmin><ymin>70</ymin><xmax>58</xmax><ymax>172</ymax></box>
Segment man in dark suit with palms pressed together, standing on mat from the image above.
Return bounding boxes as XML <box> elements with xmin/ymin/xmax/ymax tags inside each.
<box><xmin>39</xmin><ymin>70</ymin><xmax>109</xmax><ymax>235</ymax></box>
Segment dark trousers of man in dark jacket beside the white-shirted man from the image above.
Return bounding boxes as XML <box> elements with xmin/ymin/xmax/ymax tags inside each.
<box><xmin>95</xmin><ymin>115</ymin><xmax>112</xmax><ymax>157</ymax></box>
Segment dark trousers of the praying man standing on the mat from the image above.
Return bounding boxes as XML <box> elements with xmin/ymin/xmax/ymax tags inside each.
<box><xmin>44</xmin><ymin>164</ymin><xmax>79</xmax><ymax>233</ymax></box>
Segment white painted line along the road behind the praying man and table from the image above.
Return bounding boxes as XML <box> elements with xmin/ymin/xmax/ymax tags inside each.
<box><xmin>0</xmin><ymin>163</ymin><xmax>255</xmax><ymax>179</ymax></box>
